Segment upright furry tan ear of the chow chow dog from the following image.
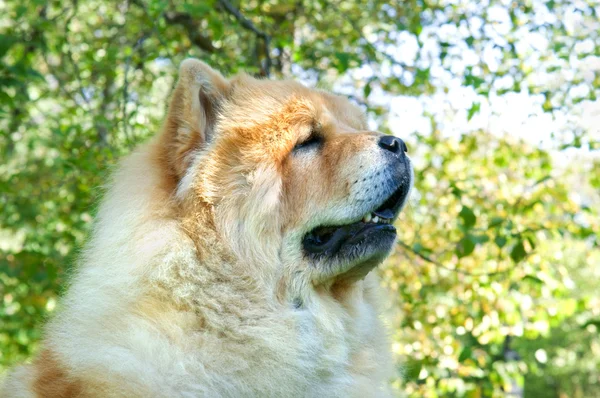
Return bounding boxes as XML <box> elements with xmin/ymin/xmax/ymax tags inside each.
<box><xmin>161</xmin><ymin>58</ymin><xmax>230</xmax><ymax>180</ymax></box>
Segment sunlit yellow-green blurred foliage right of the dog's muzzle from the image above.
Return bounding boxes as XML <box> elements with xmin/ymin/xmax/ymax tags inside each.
<box><xmin>383</xmin><ymin>133</ymin><xmax>600</xmax><ymax>397</ymax></box>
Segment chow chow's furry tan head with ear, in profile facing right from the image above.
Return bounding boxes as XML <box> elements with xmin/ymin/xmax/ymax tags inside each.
<box><xmin>163</xmin><ymin>60</ymin><xmax>413</xmax><ymax>293</ymax></box>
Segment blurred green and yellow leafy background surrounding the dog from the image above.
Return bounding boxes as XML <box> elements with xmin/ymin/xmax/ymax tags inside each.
<box><xmin>0</xmin><ymin>0</ymin><xmax>600</xmax><ymax>398</ymax></box>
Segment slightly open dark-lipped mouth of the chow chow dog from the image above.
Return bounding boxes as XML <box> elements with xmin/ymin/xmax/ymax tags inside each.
<box><xmin>303</xmin><ymin>184</ymin><xmax>408</xmax><ymax>260</ymax></box>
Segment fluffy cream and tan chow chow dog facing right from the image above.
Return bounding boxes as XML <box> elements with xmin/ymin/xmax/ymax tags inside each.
<box><xmin>0</xmin><ymin>59</ymin><xmax>413</xmax><ymax>398</ymax></box>
